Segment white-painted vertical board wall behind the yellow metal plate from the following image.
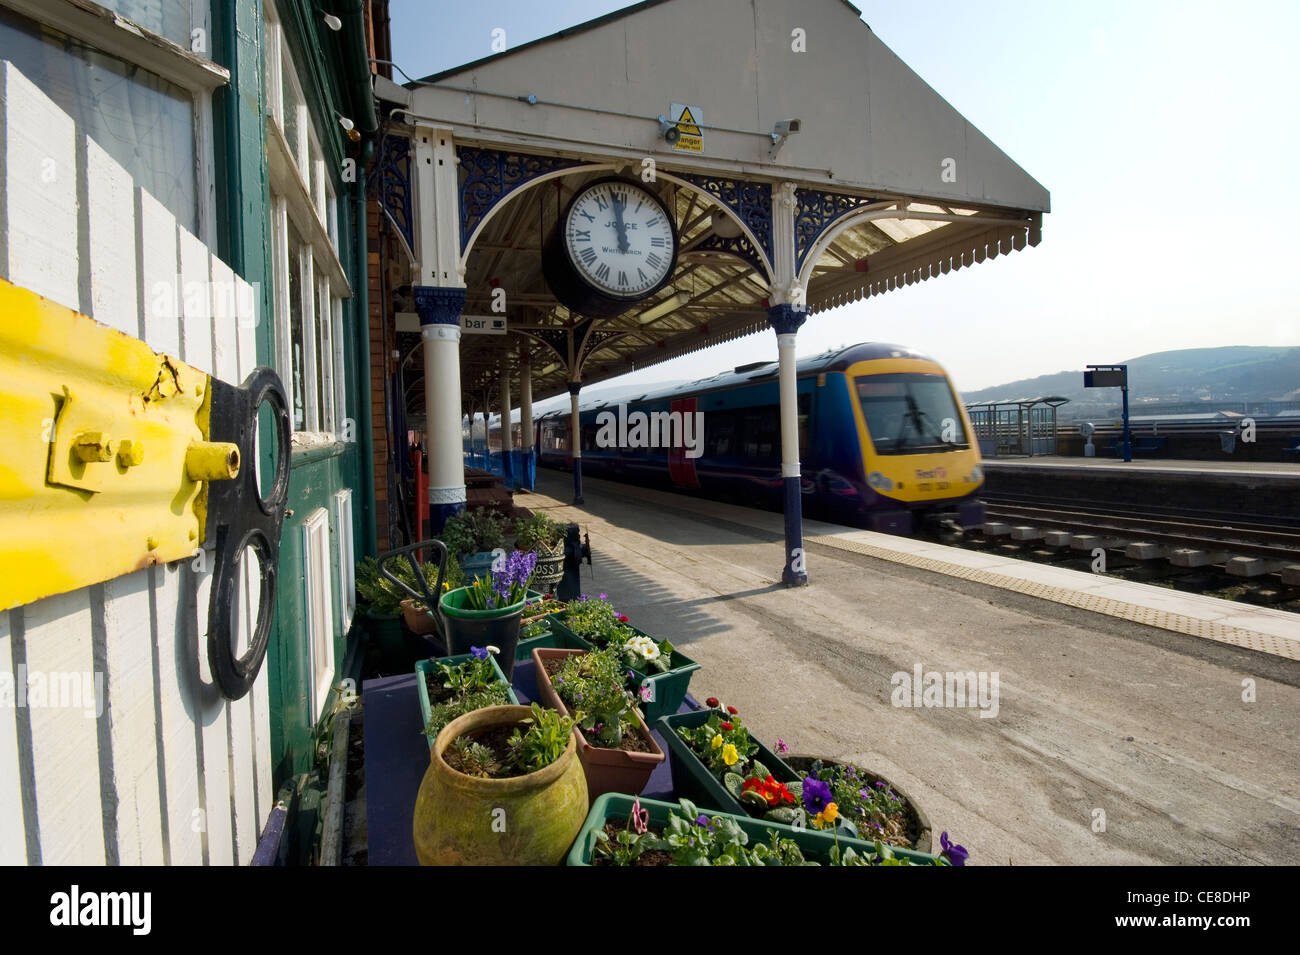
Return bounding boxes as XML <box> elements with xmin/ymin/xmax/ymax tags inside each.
<box><xmin>0</xmin><ymin>61</ymin><xmax>274</xmax><ymax>865</ymax></box>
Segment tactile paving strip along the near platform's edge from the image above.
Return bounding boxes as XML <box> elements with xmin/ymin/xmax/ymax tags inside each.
<box><xmin>805</xmin><ymin>535</ymin><xmax>1300</xmax><ymax>660</ymax></box>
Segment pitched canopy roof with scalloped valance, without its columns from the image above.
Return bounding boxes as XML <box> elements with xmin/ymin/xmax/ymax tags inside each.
<box><xmin>397</xmin><ymin>0</ymin><xmax>1049</xmax><ymax>414</ymax></box>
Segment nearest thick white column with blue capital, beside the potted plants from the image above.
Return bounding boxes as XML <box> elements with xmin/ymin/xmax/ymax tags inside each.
<box><xmin>413</xmin><ymin>286</ymin><xmax>473</xmax><ymax>537</ymax></box>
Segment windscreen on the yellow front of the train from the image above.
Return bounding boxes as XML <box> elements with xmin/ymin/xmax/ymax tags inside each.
<box><xmin>855</xmin><ymin>373</ymin><xmax>970</xmax><ymax>455</ymax></box>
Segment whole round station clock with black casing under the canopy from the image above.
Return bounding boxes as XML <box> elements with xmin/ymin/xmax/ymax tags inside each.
<box><xmin>542</xmin><ymin>177</ymin><xmax>677</xmax><ymax>317</ymax></box>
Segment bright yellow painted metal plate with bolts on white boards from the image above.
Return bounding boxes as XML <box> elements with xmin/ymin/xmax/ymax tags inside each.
<box><xmin>0</xmin><ymin>279</ymin><xmax>208</xmax><ymax>609</ymax></box>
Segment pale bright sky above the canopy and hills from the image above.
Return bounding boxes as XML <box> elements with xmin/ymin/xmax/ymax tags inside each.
<box><xmin>391</xmin><ymin>0</ymin><xmax>1300</xmax><ymax>400</ymax></box>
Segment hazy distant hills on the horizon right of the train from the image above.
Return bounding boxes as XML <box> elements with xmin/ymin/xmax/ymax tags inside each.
<box><xmin>962</xmin><ymin>346</ymin><xmax>1300</xmax><ymax>414</ymax></box>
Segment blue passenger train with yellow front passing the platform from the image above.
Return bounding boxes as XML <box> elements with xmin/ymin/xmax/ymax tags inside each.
<box><xmin>517</xmin><ymin>343</ymin><xmax>984</xmax><ymax>535</ymax></box>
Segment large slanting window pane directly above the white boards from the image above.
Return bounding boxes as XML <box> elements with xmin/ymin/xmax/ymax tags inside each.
<box><xmin>0</xmin><ymin>4</ymin><xmax>199</xmax><ymax>233</ymax></box>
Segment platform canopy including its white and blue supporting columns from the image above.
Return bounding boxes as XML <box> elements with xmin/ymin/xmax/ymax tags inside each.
<box><xmin>378</xmin><ymin>0</ymin><xmax>1049</xmax><ymax>585</ymax></box>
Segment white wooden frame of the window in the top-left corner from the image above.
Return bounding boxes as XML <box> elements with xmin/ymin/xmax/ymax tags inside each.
<box><xmin>0</xmin><ymin>0</ymin><xmax>230</xmax><ymax>248</ymax></box>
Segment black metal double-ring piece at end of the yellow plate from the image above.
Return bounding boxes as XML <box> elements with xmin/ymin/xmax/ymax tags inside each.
<box><xmin>205</xmin><ymin>365</ymin><xmax>291</xmax><ymax>699</ymax></box>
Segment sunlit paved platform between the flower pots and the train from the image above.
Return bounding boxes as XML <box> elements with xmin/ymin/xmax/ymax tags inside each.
<box><xmin>516</xmin><ymin>470</ymin><xmax>1300</xmax><ymax>865</ymax></box>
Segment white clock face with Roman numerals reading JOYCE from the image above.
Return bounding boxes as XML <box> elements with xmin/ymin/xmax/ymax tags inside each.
<box><xmin>562</xmin><ymin>179</ymin><xmax>677</xmax><ymax>301</ymax></box>
